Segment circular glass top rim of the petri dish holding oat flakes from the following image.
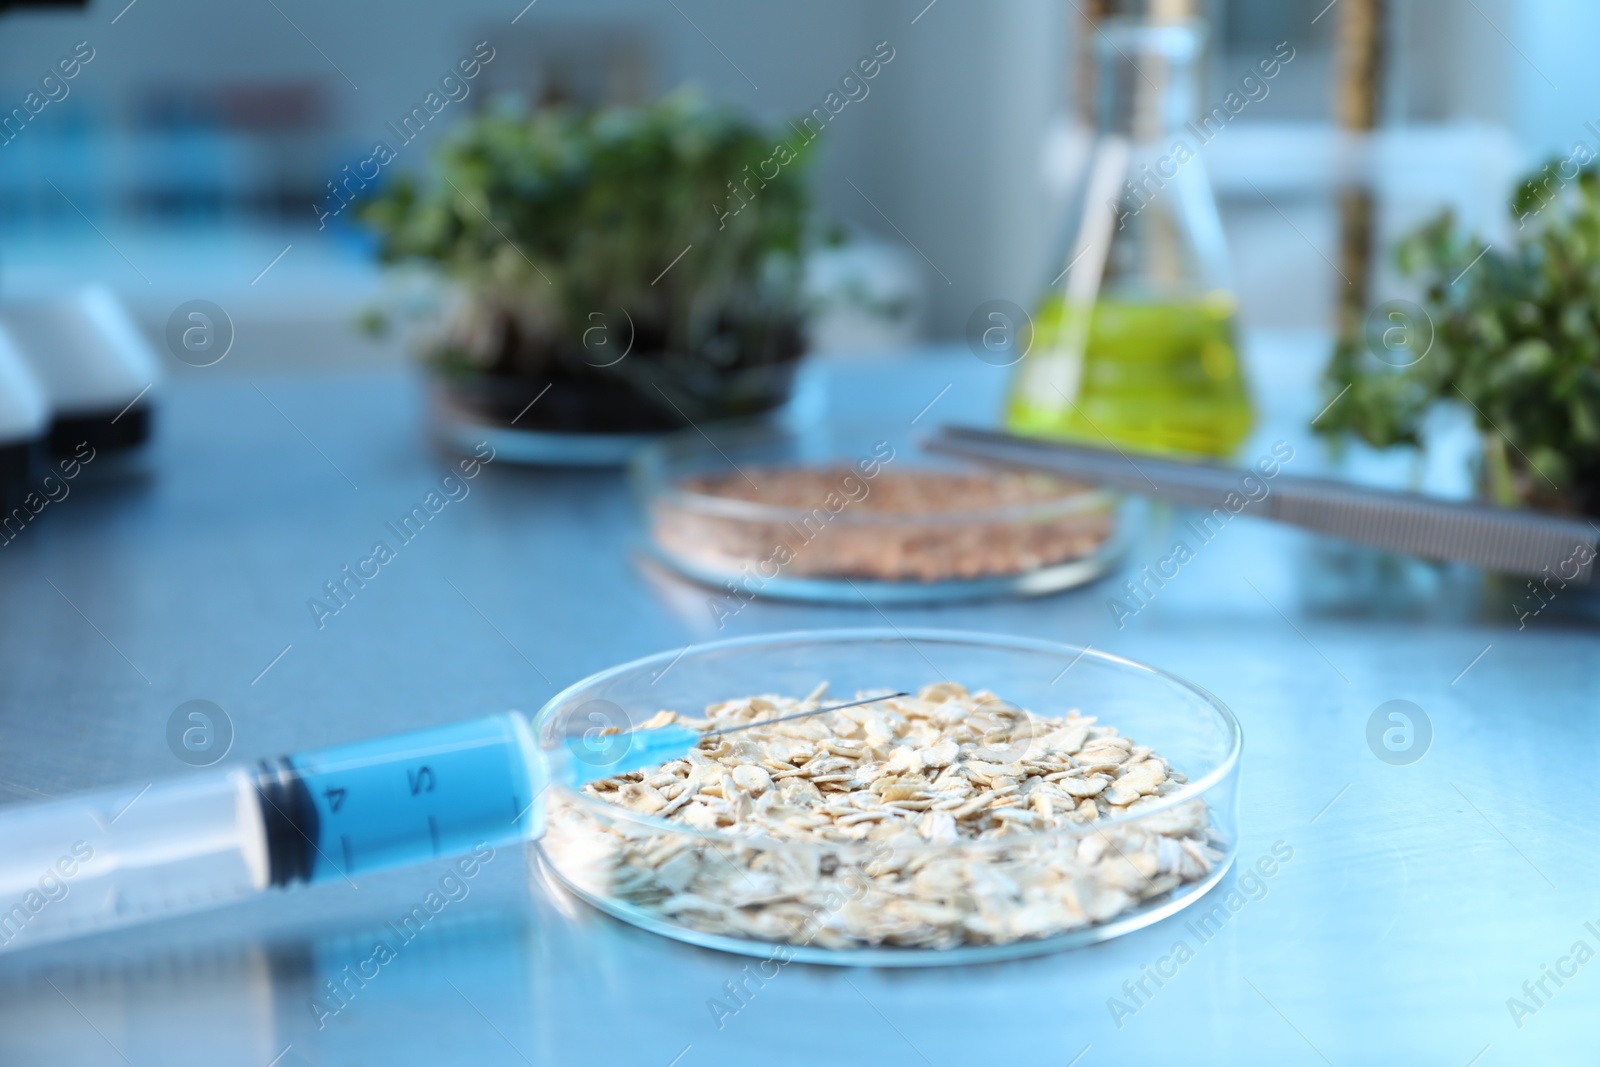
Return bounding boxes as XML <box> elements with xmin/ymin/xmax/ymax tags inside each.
<box><xmin>533</xmin><ymin>627</ymin><xmax>1245</xmax><ymax>854</ymax></box>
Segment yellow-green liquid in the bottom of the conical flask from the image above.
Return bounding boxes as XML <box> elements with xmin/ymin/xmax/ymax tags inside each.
<box><xmin>1006</xmin><ymin>293</ymin><xmax>1253</xmax><ymax>456</ymax></box>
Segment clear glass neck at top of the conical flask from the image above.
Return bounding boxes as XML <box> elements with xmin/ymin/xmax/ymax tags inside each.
<box><xmin>1094</xmin><ymin>18</ymin><xmax>1203</xmax><ymax>141</ymax></box>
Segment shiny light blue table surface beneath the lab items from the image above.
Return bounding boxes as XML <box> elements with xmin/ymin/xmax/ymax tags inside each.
<box><xmin>0</xmin><ymin>336</ymin><xmax>1600</xmax><ymax>1067</ymax></box>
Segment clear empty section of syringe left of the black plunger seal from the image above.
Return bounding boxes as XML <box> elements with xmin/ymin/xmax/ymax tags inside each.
<box><xmin>0</xmin><ymin>768</ymin><xmax>269</xmax><ymax>950</ymax></box>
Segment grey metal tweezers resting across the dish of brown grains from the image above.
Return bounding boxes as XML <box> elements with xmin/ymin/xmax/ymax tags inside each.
<box><xmin>922</xmin><ymin>426</ymin><xmax>1600</xmax><ymax>584</ymax></box>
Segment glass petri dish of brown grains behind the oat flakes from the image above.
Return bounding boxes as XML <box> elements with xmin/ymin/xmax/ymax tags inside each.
<box><xmin>634</xmin><ymin>422</ymin><xmax>1122</xmax><ymax>611</ymax></box>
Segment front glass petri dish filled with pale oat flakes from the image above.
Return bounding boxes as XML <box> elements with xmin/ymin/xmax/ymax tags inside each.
<box><xmin>534</xmin><ymin>630</ymin><xmax>1242</xmax><ymax>966</ymax></box>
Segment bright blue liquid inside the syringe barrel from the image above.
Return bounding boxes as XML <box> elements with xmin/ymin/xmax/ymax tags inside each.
<box><xmin>288</xmin><ymin>712</ymin><xmax>539</xmax><ymax>881</ymax></box>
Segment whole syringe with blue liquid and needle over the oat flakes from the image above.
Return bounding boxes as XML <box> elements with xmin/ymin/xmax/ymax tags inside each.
<box><xmin>0</xmin><ymin>693</ymin><xmax>904</xmax><ymax>952</ymax></box>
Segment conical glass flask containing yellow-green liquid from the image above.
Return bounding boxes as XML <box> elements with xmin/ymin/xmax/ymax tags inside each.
<box><xmin>1006</xmin><ymin>18</ymin><xmax>1251</xmax><ymax>454</ymax></box>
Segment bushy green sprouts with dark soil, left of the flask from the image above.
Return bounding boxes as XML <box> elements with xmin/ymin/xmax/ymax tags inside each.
<box><xmin>362</xmin><ymin>91</ymin><xmax>810</xmax><ymax>459</ymax></box>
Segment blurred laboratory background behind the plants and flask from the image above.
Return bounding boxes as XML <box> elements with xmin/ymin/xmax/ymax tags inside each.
<box><xmin>0</xmin><ymin>0</ymin><xmax>1574</xmax><ymax>373</ymax></box>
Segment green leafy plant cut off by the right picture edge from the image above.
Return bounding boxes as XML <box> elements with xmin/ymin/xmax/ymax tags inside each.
<box><xmin>1317</xmin><ymin>162</ymin><xmax>1600</xmax><ymax>515</ymax></box>
